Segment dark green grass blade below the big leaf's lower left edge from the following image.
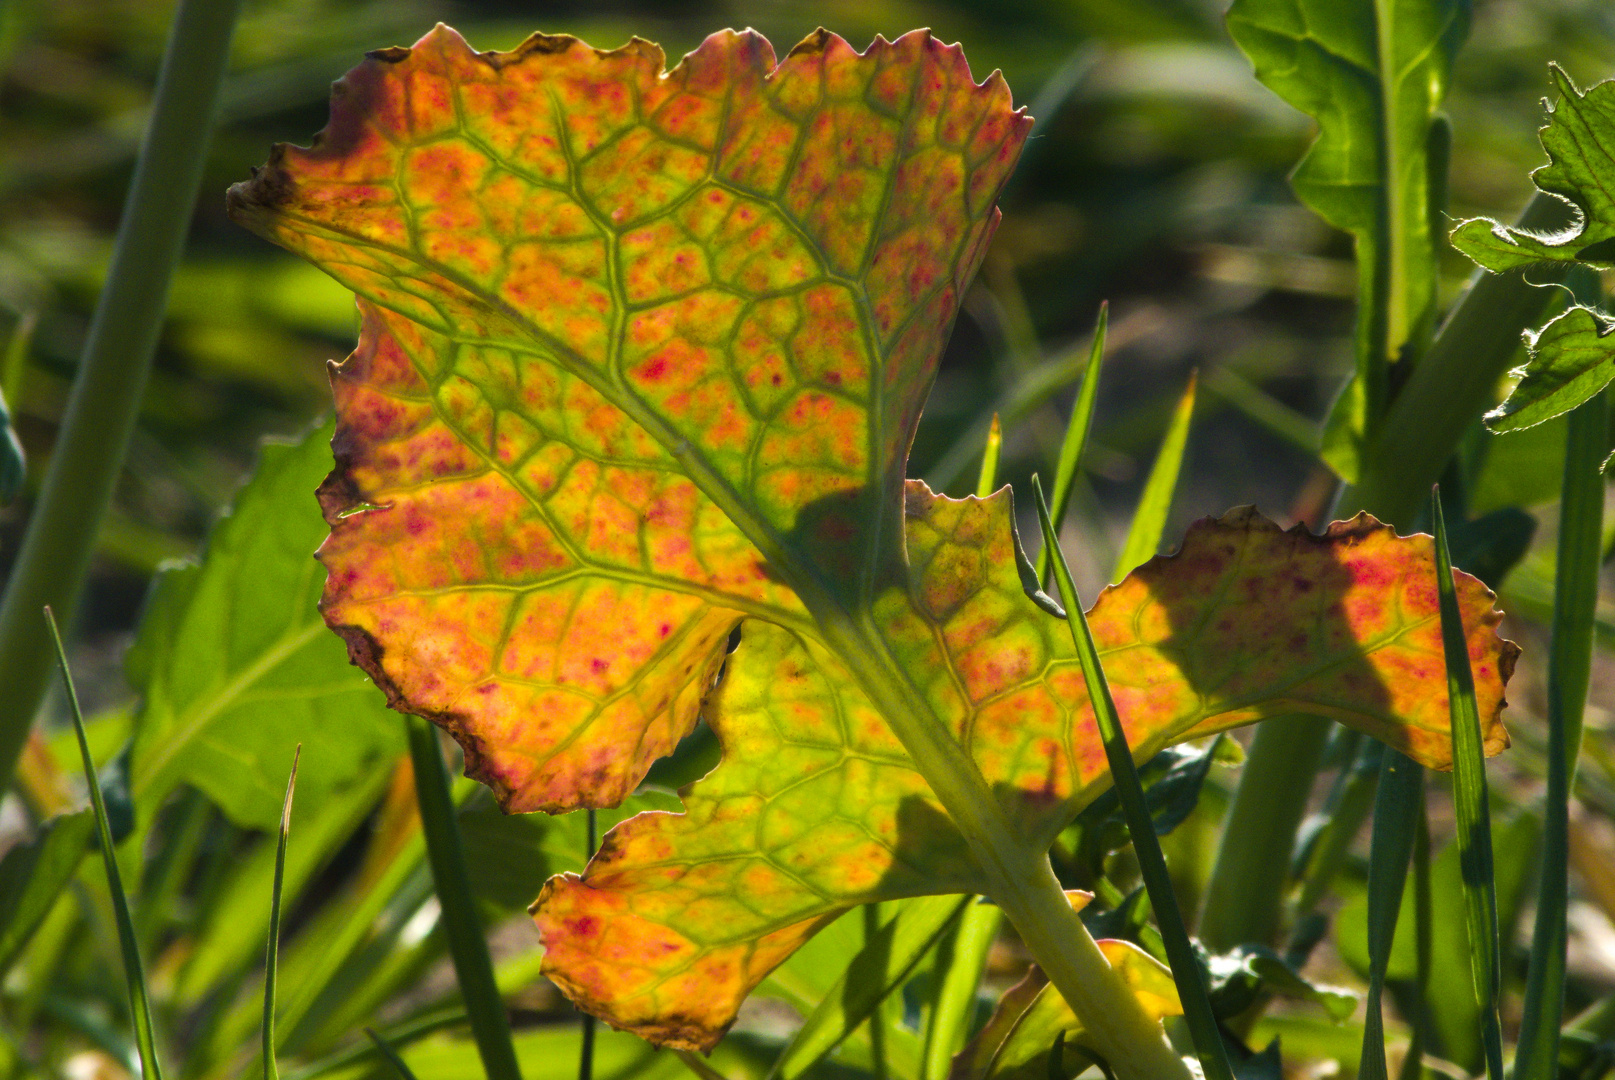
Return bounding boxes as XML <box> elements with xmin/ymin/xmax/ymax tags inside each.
<box><xmin>405</xmin><ymin>715</ymin><xmax>522</xmax><ymax>1080</ymax></box>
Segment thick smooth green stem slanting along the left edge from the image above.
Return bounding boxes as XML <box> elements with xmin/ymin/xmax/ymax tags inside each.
<box><xmin>0</xmin><ymin>0</ymin><xmax>241</xmax><ymax>789</ymax></box>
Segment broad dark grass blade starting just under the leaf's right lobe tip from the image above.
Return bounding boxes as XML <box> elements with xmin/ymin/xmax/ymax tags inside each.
<box><xmin>1357</xmin><ymin>747</ymin><xmax>1424</xmax><ymax>1080</ymax></box>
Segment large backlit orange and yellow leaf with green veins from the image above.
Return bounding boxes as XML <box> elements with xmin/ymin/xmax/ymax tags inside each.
<box><xmin>231</xmin><ymin>27</ymin><xmax>1515</xmax><ymax>1048</ymax></box>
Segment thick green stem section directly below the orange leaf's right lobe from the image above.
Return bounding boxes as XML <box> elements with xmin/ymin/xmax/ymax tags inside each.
<box><xmin>1200</xmin><ymin>717</ymin><xmax>1329</xmax><ymax>952</ymax></box>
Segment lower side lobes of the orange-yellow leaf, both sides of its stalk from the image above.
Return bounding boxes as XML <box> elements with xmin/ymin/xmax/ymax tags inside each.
<box><xmin>533</xmin><ymin>481</ymin><xmax>1516</xmax><ymax>1048</ymax></box>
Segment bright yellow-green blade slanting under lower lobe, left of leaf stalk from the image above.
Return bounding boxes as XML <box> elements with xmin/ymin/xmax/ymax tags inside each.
<box><xmin>769</xmin><ymin>896</ymin><xmax>971</xmax><ymax>1080</ymax></box>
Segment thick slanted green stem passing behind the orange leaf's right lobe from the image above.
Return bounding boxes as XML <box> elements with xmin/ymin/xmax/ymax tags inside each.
<box><xmin>1203</xmin><ymin>194</ymin><xmax>1563</xmax><ymax>944</ymax></box>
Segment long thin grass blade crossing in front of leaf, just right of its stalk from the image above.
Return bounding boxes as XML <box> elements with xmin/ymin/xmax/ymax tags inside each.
<box><xmin>1032</xmin><ymin>476</ymin><xmax>1234</xmax><ymax>1080</ymax></box>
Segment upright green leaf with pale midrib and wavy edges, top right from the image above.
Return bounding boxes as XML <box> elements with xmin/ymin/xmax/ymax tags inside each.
<box><xmin>1227</xmin><ymin>0</ymin><xmax>1470</xmax><ymax>481</ymax></box>
